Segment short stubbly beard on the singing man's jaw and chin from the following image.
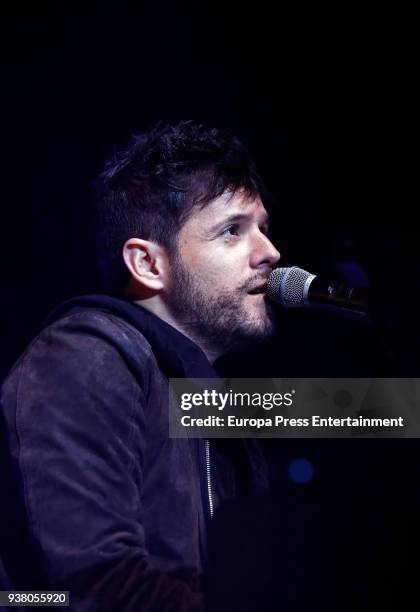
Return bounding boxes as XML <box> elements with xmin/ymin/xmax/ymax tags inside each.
<box><xmin>167</xmin><ymin>257</ymin><xmax>274</xmax><ymax>352</ymax></box>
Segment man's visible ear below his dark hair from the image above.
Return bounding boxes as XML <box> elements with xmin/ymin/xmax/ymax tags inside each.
<box><xmin>123</xmin><ymin>238</ymin><xmax>169</xmax><ymax>291</ymax></box>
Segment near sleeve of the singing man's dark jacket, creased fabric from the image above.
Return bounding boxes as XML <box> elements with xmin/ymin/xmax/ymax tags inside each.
<box><xmin>4</xmin><ymin>314</ymin><xmax>204</xmax><ymax>612</ymax></box>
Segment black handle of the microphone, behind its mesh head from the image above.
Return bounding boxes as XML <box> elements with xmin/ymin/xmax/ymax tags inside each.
<box><xmin>306</xmin><ymin>276</ymin><xmax>370</xmax><ymax>314</ymax></box>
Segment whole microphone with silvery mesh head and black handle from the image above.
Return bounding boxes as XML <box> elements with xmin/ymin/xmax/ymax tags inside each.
<box><xmin>267</xmin><ymin>266</ymin><xmax>370</xmax><ymax>314</ymax></box>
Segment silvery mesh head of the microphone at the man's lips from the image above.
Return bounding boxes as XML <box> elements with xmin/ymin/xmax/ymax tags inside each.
<box><xmin>267</xmin><ymin>266</ymin><xmax>314</xmax><ymax>308</ymax></box>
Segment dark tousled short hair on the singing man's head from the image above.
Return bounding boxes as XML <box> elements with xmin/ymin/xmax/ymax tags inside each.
<box><xmin>95</xmin><ymin>121</ymin><xmax>264</xmax><ymax>294</ymax></box>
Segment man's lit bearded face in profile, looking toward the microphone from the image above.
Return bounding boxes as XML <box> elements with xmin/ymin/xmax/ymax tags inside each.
<box><xmin>166</xmin><ymin>192</ymin><xmax>280</xmax><ymax>352</ymax></box>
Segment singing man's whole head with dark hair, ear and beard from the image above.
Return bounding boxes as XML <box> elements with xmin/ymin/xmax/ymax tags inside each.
<box><xmin>96</xmin><ymin>121</ymin><xmax>280</xmax><ymax>355</ymax></box>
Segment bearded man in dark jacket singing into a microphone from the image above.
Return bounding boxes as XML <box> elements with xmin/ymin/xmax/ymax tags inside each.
<box><xmin>2</xmin><ymin>121</ymin><xmax>280</xmax><ymax>612</ymax></box>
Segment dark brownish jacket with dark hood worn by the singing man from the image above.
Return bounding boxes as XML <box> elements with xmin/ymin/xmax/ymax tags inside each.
<box><xmin>1</xmin><ymin>296</ymin><xmax>267</xmax><ymax>612</ymax></box>
